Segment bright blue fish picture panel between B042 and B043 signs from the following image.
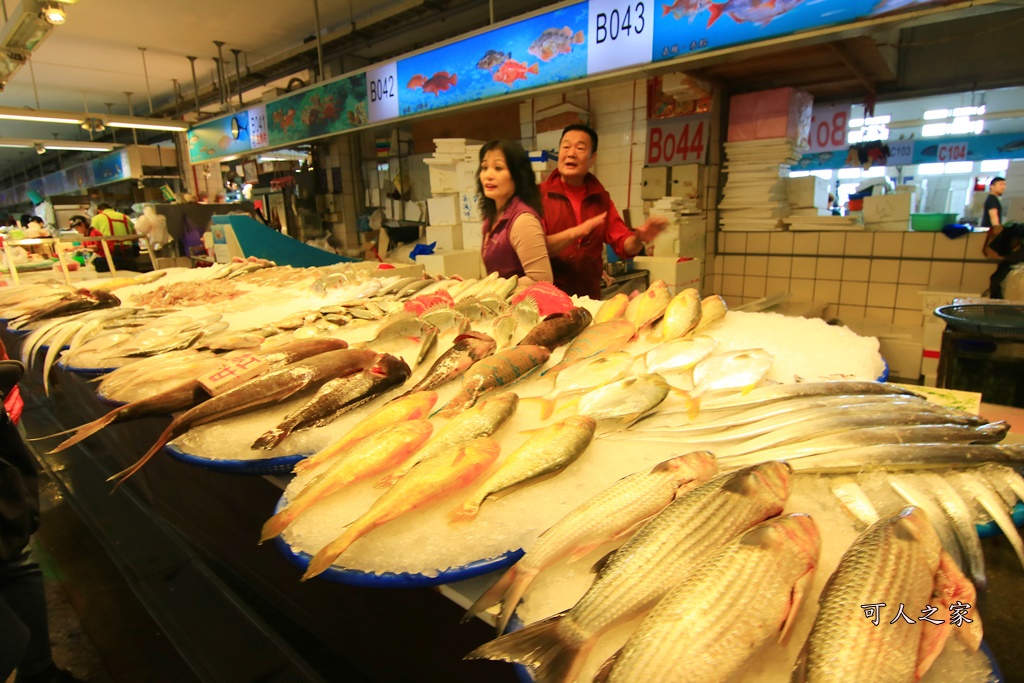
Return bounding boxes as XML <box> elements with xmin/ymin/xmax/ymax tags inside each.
<box><xmin>397</xmin><ymin>2</ymin><xmax>587</xmax><ymax>116</ymax></box>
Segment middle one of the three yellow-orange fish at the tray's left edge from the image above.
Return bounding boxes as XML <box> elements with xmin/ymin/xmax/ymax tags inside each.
<box><xmin>260</xmin><ymin>420</ymin><xmax>433</xmax><ymax>543</ymax></box>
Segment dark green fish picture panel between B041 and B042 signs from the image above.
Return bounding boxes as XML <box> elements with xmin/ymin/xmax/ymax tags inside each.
<box><xmin>266</xmin><ymin>74</ymin><xmax>370</xmax><ymax>146</ymax></box>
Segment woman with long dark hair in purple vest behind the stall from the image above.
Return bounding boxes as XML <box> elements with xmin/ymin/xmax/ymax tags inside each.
<box><xmin>476</xmin><ymin>140</ymin><xmax>553</xmax><ymax>287</ymax></box>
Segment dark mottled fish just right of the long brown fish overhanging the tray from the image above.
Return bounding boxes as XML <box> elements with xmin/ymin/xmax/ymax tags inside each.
<box><xmin>252</xmin><ymin>353</ymin><xmax>412</xmax><ymax>451</ymax></box>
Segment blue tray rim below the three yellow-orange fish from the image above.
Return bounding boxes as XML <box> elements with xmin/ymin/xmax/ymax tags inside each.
<box><xmin>273</xmin><ymin>496</ymin><xmax>524</xmax><ymax>588</ymax></box>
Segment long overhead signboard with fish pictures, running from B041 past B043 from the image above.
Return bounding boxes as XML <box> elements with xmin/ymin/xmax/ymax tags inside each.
<box><xmin>182</xmin><ymin>0</ymin><xmax>983</xmax><ymax>164</ymax></box>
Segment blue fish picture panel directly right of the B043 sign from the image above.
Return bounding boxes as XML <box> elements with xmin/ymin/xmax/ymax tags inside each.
<box><xmin>646</xmin><ymin>0</ymin><xmax>948</xmax><ymax>61</ymax></box>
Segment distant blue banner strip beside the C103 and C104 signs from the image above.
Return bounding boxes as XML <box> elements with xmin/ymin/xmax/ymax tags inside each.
<box><xmin>793</xmin><ymin>132</ymin><xmax>1024</xmax><ymax>171</ymax></box>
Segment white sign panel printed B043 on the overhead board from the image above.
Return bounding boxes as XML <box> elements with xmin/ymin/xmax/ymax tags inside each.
<box><xmin>587</xmin><ymin>0</ymin><xmax>654</xmax><ymax>76</ymax></box>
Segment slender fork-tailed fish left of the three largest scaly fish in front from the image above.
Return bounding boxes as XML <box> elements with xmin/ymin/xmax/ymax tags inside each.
<box><xmin>463</xmin><ymin>451</ymin><xmax>718</xmax><ymax>635</ymax></box>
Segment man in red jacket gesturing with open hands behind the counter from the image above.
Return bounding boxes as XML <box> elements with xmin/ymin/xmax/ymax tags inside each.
<box><xmin>541</xmin><ymin>124</ymin><xmax>668</xmax><ymax>299</ymax></box>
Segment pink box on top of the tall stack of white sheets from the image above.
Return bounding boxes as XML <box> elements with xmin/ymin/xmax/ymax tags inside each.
<box><xmin>728</xmin><ymin>88</ymin><xmax>814</xmax><ymax>145</ymax></box>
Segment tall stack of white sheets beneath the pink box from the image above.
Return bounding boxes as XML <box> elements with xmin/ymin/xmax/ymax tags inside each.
<box><xmin>718</xmin><ymin>137</ymin><xmax>803</xmax><ymax>231</ymax></box>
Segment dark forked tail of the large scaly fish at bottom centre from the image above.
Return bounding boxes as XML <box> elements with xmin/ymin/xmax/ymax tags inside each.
<box><xmin>466</xmin><ymin>612</ymin><xmax>593</xmax><ymax>682</ymax></box>
